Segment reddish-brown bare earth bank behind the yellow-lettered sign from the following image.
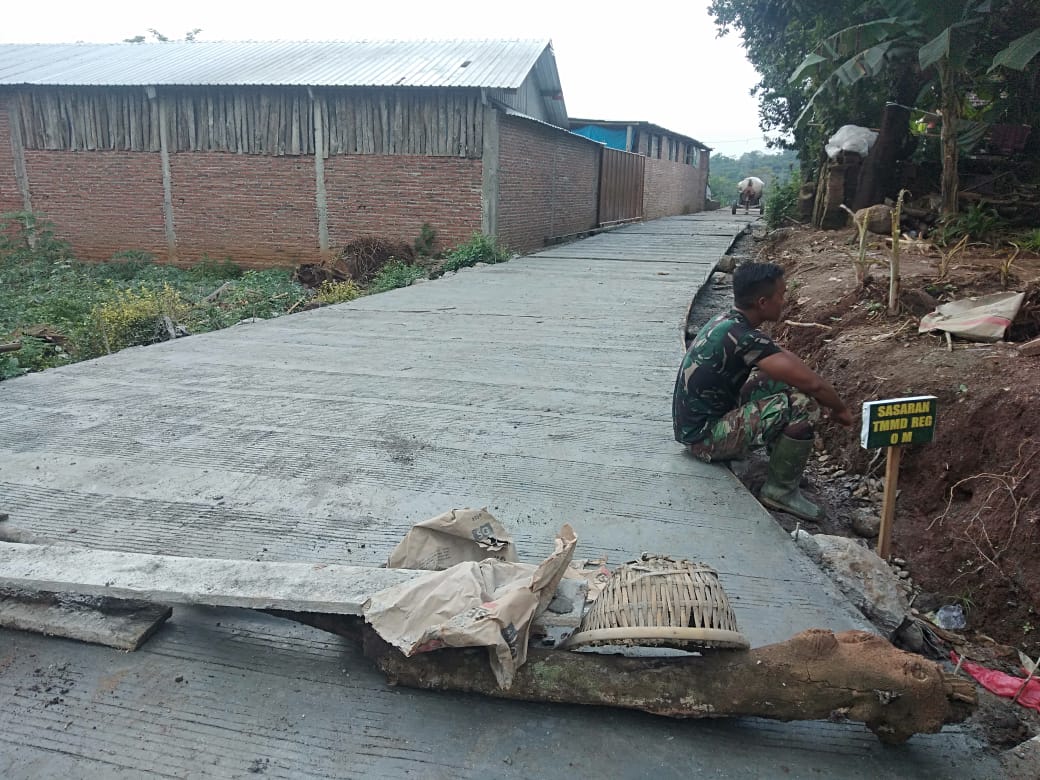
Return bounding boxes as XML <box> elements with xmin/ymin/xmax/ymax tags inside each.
<box><xmin>703</xmin><ymin>227</ymin><xmax>1040</xmax><ymax>761</ymax></box>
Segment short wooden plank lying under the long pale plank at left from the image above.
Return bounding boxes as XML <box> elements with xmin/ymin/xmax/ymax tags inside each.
<box><xmin>0</xmin><ymin>590</ymin><xmax>174</xmax><ymax>651</ymax></box>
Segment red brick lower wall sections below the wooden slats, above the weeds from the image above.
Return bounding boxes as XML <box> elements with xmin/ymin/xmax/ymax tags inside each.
<box><xmin>0</xmin><ymin>142</ymin><xmax>482</xmax><ymax>267</ymax></box>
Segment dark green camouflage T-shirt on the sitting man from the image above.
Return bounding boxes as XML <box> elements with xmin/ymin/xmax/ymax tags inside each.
<box><xmin>672</xmin><ymin>309</ymin><xmax>780</xmax><ymax>444</ymax></box>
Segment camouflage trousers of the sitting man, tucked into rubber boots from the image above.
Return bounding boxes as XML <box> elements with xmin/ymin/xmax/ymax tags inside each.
<box><xmin>690</xmin><ymin>373</ymin><xmax>820</xmax><ymax>463</ymax></box>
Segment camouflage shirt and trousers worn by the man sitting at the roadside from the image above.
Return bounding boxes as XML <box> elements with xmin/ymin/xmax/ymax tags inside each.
<box><xmin>672</xmin><ymin>309</ymin><xmax>820</xmax><ymax>462</ymax></box>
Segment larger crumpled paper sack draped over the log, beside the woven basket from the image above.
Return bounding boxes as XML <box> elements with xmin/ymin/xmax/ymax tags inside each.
<box><xmin>363</xmin><ymin>525</ymin><xmax>577</xmax><ymax>688</ymax></box>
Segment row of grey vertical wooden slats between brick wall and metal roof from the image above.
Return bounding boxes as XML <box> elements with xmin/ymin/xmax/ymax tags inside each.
<box><xmin>16</xmin><ymin>86</ymin><xmax>484</xmax><ymax>158</ymax></box>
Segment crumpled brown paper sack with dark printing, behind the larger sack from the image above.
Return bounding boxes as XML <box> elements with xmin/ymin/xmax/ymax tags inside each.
<box><xmin>387</xmin><ymin>509</ymin><xmax>517</xmax><ymax>571</ymax></box>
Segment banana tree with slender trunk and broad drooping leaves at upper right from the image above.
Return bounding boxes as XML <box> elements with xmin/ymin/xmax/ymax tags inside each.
<box><xmin>790</xmin><ymin>0</ymin><xmax>992</xmax><ymax>216</ymax></box>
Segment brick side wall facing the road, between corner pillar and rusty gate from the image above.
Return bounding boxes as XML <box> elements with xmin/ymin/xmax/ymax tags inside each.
<box><xmin>498</xmin><ymin>115</ymin><xmax>600</xmax><ymax>252</ymax></box>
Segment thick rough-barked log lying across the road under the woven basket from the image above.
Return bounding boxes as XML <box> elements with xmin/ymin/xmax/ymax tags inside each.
<box><xmin>364</xmin><ymin>626</ymin><xmax>978</xmax><ymax>744</ymax></box>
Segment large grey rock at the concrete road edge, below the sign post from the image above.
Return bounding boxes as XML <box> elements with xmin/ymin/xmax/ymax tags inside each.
<box><xmin>796</xmin><ymin>534</ymin><xmax>910</xmax><ymax>635</ymax></box>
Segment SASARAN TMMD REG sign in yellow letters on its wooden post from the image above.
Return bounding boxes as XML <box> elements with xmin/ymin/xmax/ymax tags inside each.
<box><xmin>860</xmin><ymin>395</ymin><xmax>938</xmax><ymax>560</ymax></box>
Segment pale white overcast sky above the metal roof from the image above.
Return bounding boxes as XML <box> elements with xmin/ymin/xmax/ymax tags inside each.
<box><xmin>0</xmin><ymin>0</ymin><xmax>765</xmax><ymax>156</ymax></box>
